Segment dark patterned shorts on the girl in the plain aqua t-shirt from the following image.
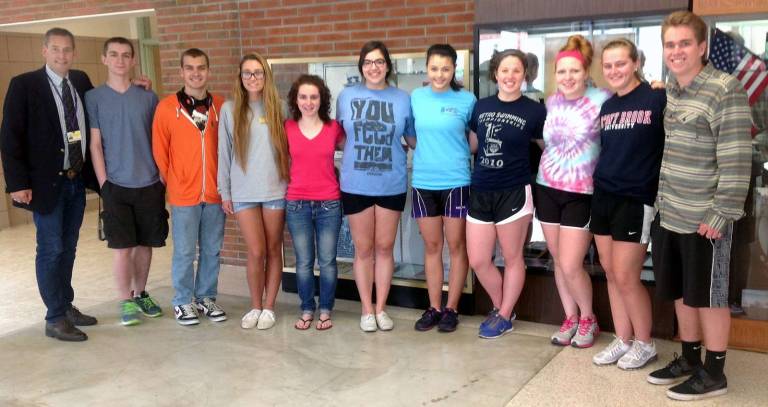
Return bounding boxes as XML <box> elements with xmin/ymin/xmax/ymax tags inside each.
<box><xmin>411</xmin><ymin>186</ymin><xmax>469</xmax><ymax>219</ymax></box>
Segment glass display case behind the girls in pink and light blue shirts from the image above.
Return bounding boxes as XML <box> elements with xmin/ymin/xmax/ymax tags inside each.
<box><xmin>269</xmin><ymin>50</ymin><xmax>473</xmax><ymax>298</ymax></box>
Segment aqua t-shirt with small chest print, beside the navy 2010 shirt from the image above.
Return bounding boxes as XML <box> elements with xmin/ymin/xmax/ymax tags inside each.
<box><xmin>411</xmin><ymin>86</ymin><xmax>476</xmax><ymax>190</ymax></box>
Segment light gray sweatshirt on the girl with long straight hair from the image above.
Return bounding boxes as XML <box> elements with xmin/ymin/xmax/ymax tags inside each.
<box><xmin>218</xmin><ymin>100</ymin><xmax>287</xmax><ymax>202</ymax></box>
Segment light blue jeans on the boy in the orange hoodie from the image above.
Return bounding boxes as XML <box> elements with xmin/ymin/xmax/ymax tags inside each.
<box><xmin>171</xmin><ymin>203</ymin><xmax>225</xmax><ymax>307</ymax></box>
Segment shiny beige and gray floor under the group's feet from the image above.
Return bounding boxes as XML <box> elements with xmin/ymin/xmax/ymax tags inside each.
<box><xmin>0</xmin><ymin>212</ymin><xmax>768</xmax><ymax>407</ymax></box>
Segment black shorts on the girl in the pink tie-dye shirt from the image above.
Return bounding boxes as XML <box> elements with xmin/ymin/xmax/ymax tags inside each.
<box><xmin>534</xmin><ymin>184</ymin><xmax>592</xmax><ymax>229</ymax></box>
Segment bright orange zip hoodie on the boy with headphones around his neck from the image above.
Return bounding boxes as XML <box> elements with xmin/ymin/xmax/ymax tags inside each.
<box><xmin>152</xmin><ymin>93</ymin><xmax>224</xmax><ymax>206</ymax></box>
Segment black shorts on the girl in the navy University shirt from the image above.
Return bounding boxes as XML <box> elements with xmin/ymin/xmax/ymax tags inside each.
<box><xmin>589</xmin><ymin>188</ymin><xmax>656</xmax><ymax>244</ymax></box>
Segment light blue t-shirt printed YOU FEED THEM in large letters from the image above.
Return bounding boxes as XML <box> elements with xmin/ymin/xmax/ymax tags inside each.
<box><xmin>336</xmin><ymin>85</ymin><xmax>414</xmax><ymax>196</ymax></box>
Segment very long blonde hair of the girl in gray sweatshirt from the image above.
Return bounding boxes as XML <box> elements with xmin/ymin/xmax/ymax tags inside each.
<box><xmin>232</xmin><ymin>52</ymin><xmax>289</xmax><ymax>181</ymax></box>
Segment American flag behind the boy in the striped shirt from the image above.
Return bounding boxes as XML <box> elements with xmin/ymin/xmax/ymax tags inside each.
<box><xmin>709</xmin><ymin>29</ymin><xmax>768</xmax><ymax>105</ymax></box>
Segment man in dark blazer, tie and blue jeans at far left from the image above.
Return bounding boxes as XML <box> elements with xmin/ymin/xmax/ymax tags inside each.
<box><xmin>0</xmin><ymin>28</ymin><xmax>98</xmax><ymax>341</ymax></box>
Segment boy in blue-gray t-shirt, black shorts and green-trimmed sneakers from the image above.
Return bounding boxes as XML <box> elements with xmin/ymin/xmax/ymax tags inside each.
<box><xmin>85</xmin><ymin>37</ymin><xmax>168</xmax><ymax>326</ymax></box>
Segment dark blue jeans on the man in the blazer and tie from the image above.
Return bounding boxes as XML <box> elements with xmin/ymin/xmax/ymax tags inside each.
<box><xmin>32</xmin><ymin>177</ymin><xmax>85</xmax><ymax>322</ymax></box>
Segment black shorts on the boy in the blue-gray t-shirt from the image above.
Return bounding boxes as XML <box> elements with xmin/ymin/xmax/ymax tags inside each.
<box><xmin>101</xmin><ymin>181</ymin><xmax>168</xmax><ymax>249</ymax></box>
